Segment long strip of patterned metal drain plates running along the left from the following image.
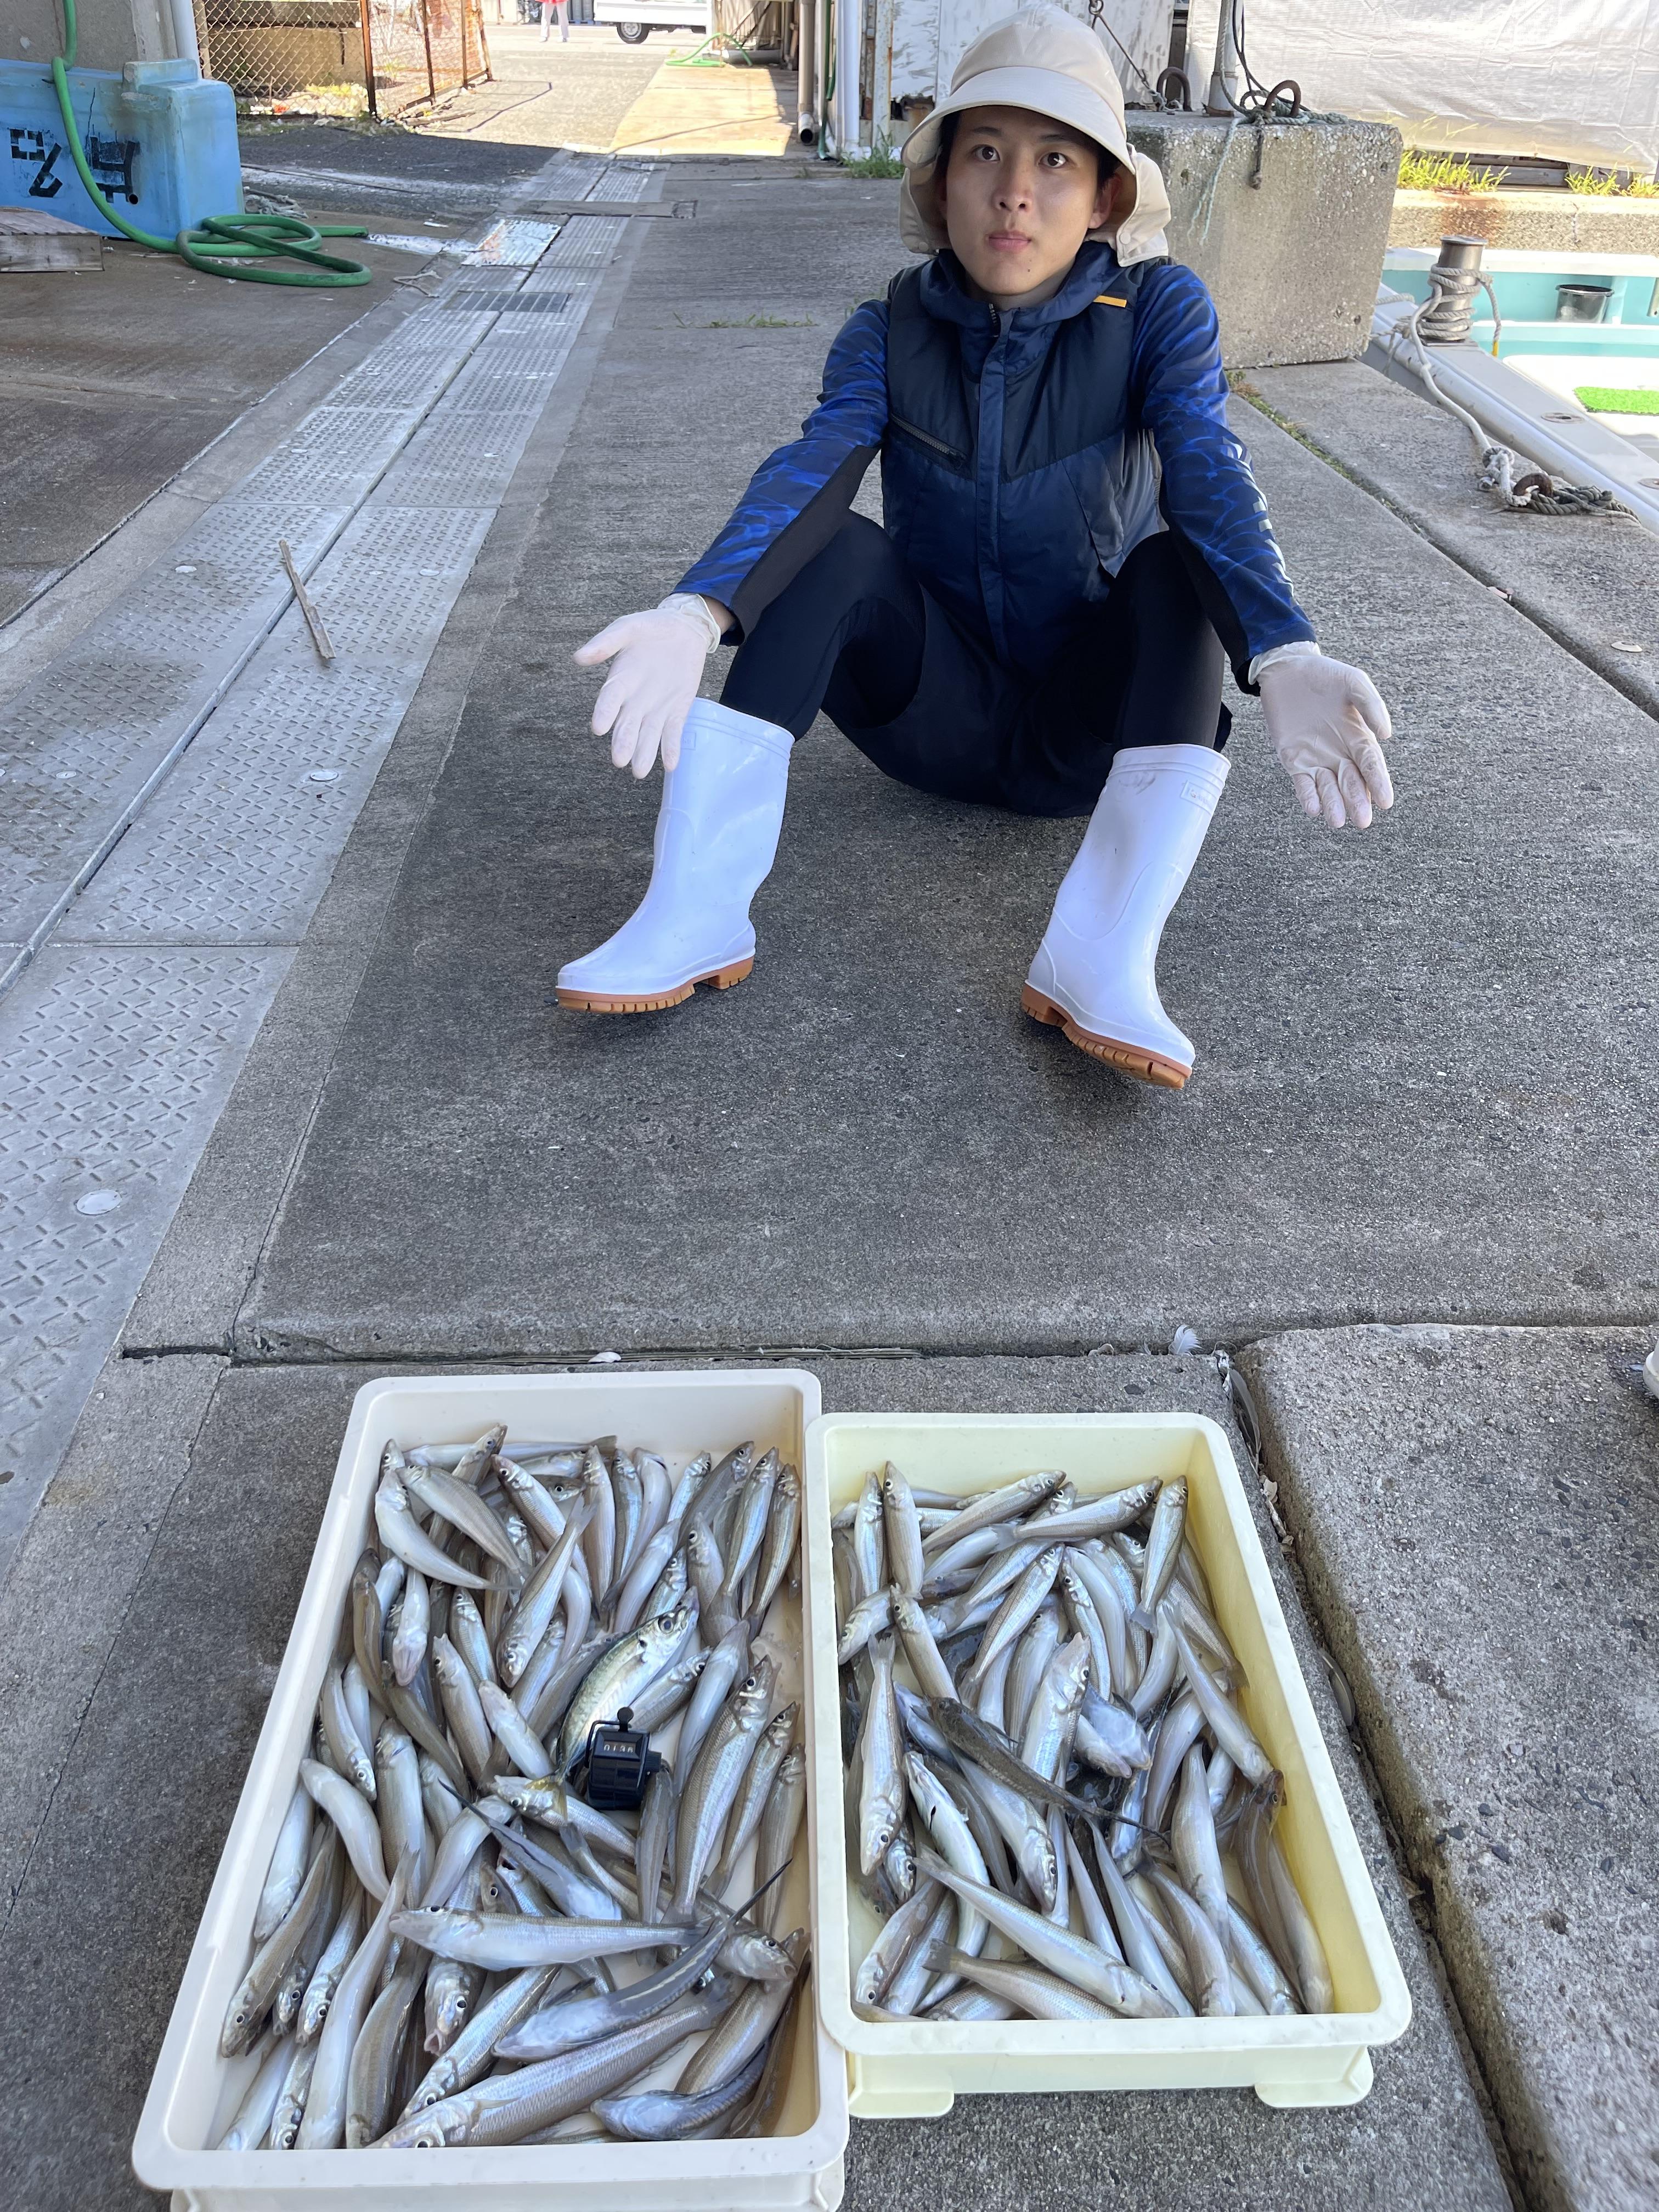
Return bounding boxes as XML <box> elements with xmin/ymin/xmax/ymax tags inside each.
<box><xmin>0</xmin><ymin>161</ymin><xmax>663</xmax><ymax>1573</ymax></box>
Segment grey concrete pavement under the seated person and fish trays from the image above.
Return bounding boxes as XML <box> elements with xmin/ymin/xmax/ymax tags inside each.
<box><xmin>0</xmin><ymin>108</ymin><xmax>1659</xmax><ymax>2212</ymax></box>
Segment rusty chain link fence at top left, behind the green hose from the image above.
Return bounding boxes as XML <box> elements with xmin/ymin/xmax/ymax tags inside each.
<box><xmin>193</xmin><ymin>0</ymin><xmax>489</xmax><ymax>115</ymax></box>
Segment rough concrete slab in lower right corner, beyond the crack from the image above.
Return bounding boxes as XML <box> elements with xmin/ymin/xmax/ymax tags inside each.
<box><xmin>1243</xmin><ymin>1327</ymin><xmax>1659</xmax><ymax>2212</ymax></box>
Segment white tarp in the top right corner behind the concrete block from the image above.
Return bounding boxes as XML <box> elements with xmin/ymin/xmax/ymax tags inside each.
<box><xmin>1188</xmin><ymin>0</ymin><xmax>1659</xmax><ymax>172</ymax></box>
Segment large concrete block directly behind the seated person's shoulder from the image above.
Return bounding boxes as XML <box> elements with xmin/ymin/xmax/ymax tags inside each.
<box><xmin>1128</xmin><ymin>111</ymin><xmax>1400</xmax><ymax>369</ymax></box>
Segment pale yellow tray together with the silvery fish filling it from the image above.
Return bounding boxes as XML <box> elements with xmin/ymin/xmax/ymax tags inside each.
<box><xmin>805</xmin><ymin>1413</ymin><xmax>1411</xmax><ymax>2117</ymax></box>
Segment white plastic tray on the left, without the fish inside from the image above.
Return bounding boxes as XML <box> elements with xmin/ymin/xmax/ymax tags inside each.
<box><xmin>133</xmin><ymin>1367</ymin><xmax>847</xmax><ymax>2212</ymax></box>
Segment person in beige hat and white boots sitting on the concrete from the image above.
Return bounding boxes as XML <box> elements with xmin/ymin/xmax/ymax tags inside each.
<box><xmin>557</xmin><ymin>4</ymin><xmax>1393</xmax><ymax>1091</ymax></box>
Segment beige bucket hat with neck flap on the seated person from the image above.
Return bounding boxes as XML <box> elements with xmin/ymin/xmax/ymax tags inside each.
<box><xmin>898</xmin><ymin>0</ymin><xmax>1170</xmax><ymax>268</ymax></box>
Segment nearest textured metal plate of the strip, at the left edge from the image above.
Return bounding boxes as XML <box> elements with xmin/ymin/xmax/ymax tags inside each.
<box><xmin>0</xmin><ymin>947</ymin><xmax>292</xmax><ymax>1575</ymax></box>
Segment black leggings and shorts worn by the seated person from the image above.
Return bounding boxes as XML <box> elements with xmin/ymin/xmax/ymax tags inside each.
<box><xmin>721</xmin><ymin>515</ymin><xmax>1232</xmax><ymax>814</ymax></box>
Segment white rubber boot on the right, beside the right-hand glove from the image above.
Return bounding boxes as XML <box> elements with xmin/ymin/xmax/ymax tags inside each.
<box><xmin>1022</xmin><ymin>746</ymin><xmax>1228</xmax><ymax>1091</ymax></box>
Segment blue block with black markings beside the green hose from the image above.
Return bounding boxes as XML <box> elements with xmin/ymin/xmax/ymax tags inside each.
<box><xmin>0</xmin><ymin>62</ymin><xmax>241</xmax><ymax>239</ymax></box>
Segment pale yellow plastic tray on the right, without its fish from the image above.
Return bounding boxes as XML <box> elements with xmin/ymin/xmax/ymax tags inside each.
<box><xmin>805</xmin><ymin>1413</ymin><xmax>1411</xmax><ymax>2119</ymax></box>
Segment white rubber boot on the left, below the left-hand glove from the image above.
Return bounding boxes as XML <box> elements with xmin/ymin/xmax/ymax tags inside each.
<box><xmin>557</xmin><ymin>699</ymin><xmax>794</xmax><ymax>1013</ymax></box>
